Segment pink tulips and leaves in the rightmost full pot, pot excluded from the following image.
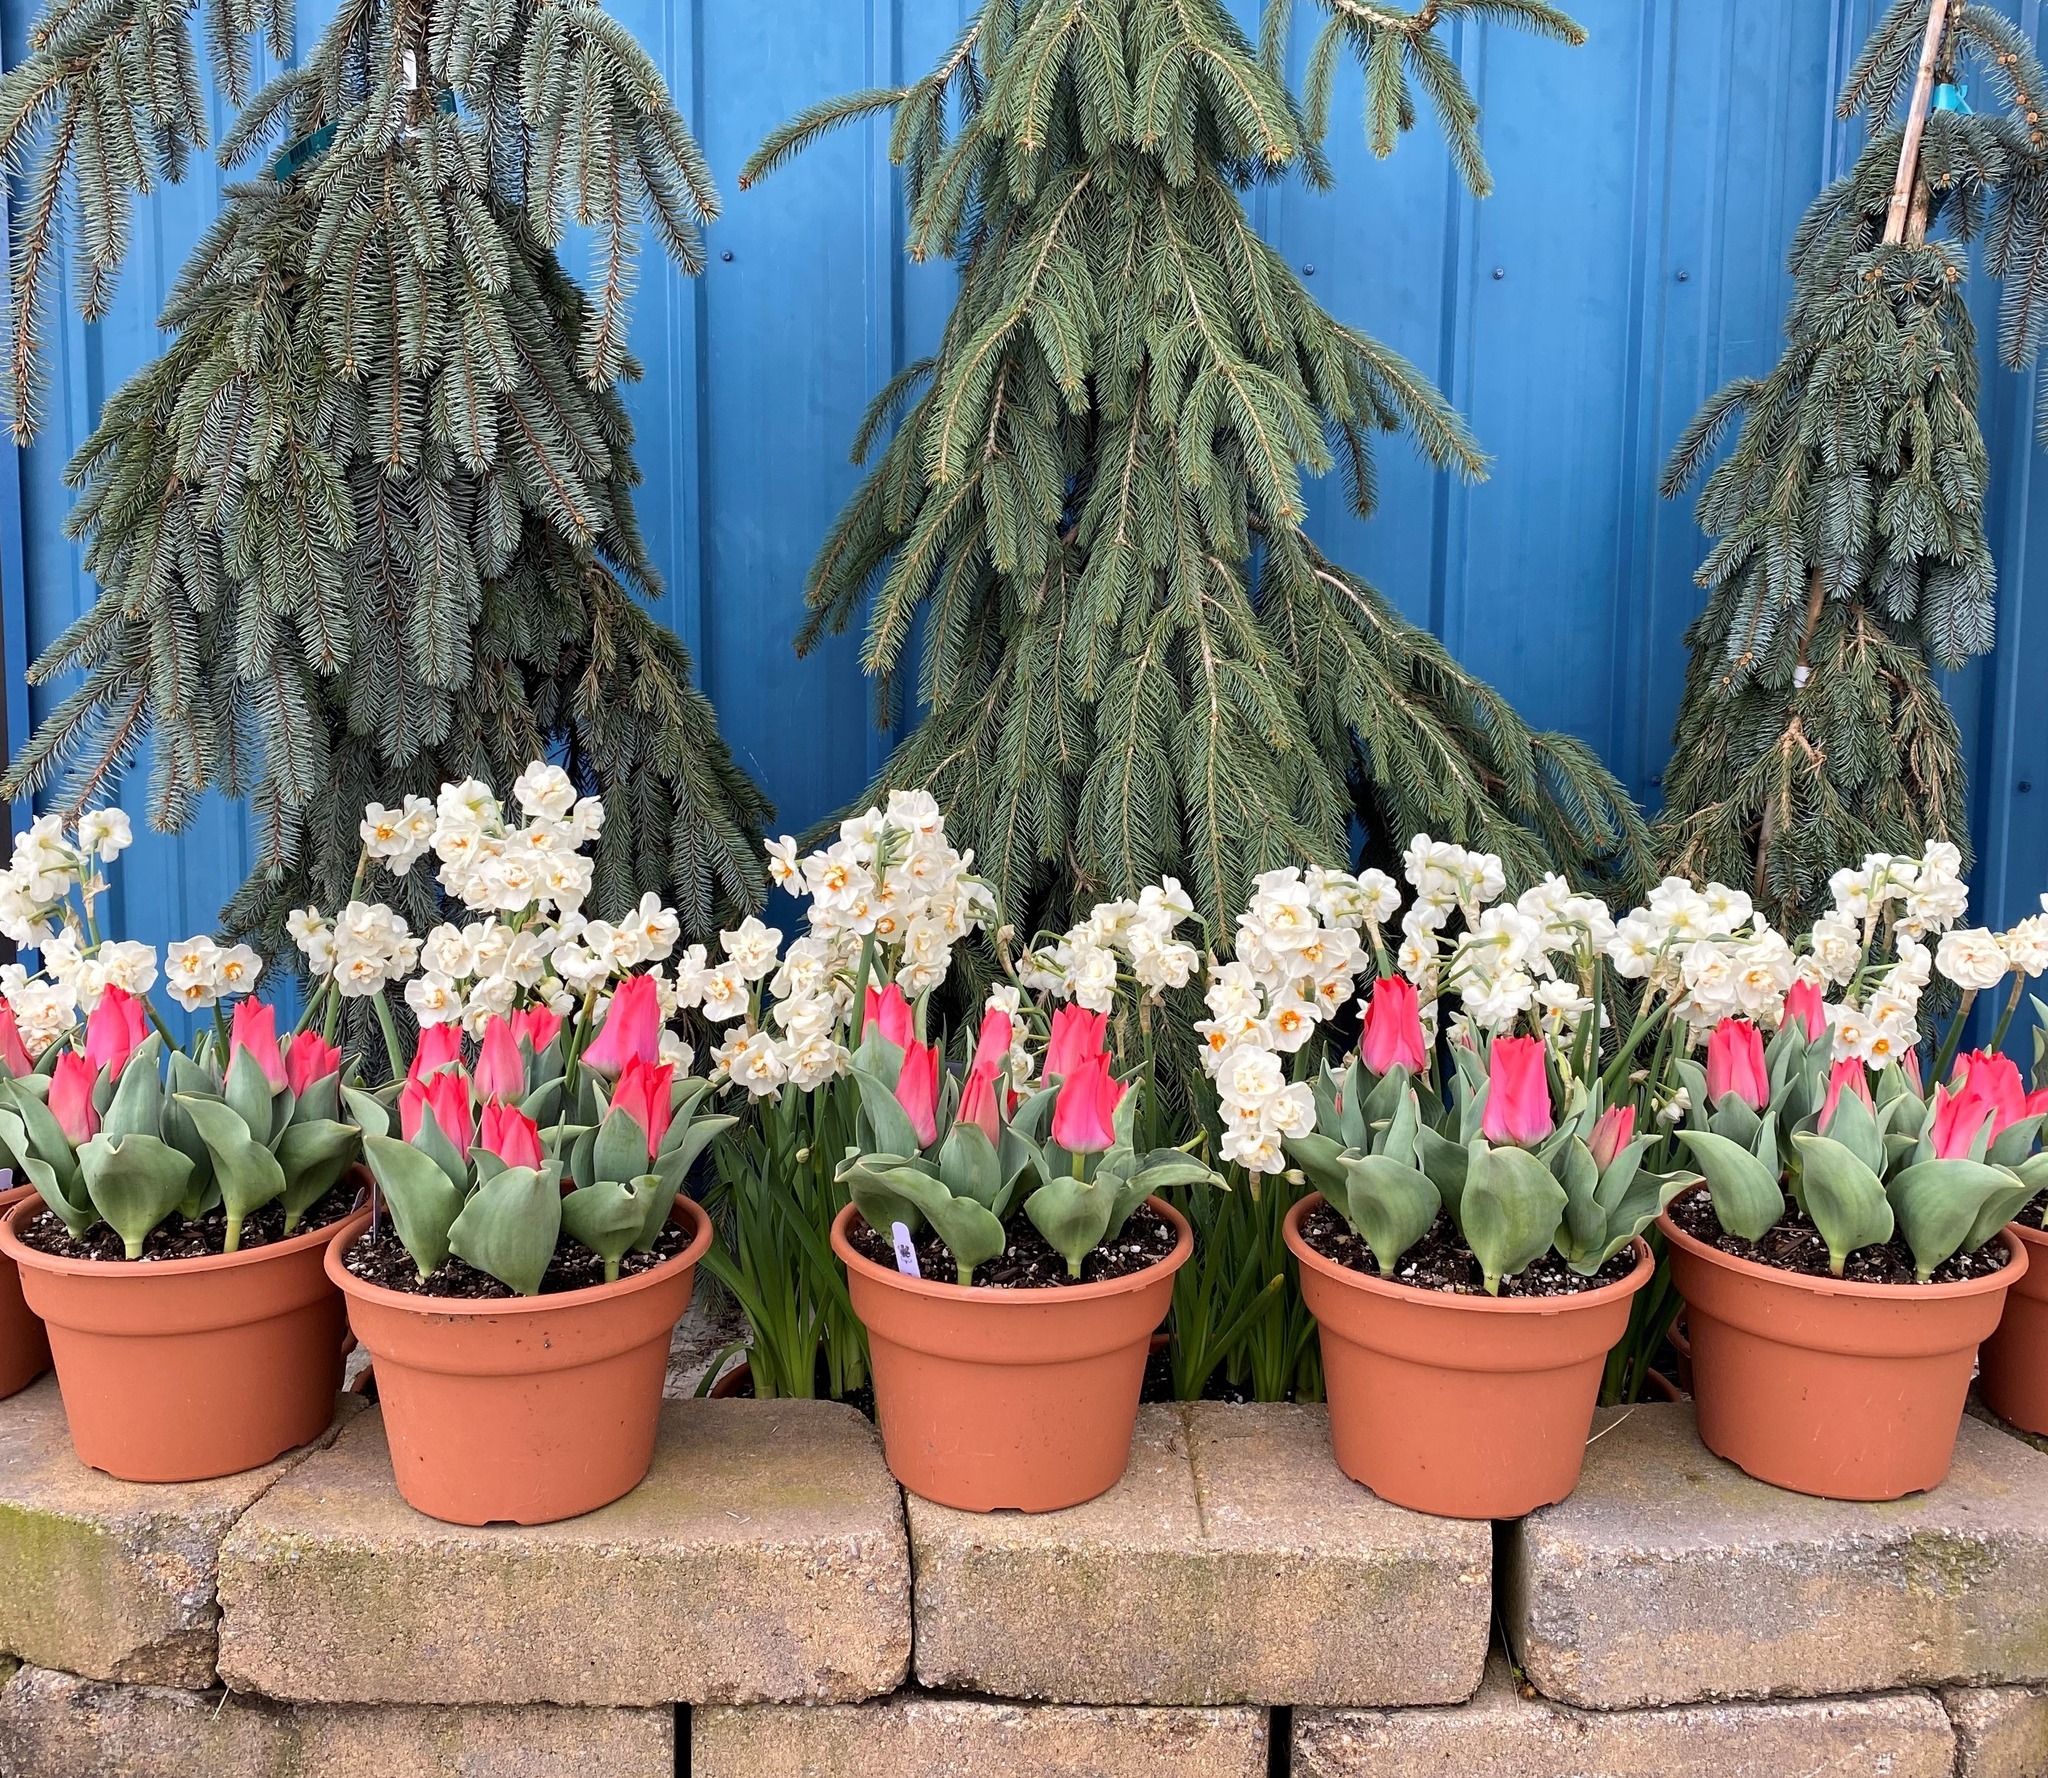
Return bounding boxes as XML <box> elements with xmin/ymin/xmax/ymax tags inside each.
<box><xmin>1677</xmin><ymin>1020</ymin><xmax>2048</xmax><ymax>1282</ymax></box>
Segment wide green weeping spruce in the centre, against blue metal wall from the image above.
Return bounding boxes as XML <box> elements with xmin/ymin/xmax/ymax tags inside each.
<box><xmin>741</xmin><ymin>0</ymin><xmax>1645</xmax><ymax>932</ymax></box>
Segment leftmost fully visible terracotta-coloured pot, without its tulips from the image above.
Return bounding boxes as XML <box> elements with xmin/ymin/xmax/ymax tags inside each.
<box><xmin>0</xmin><ymin>1200</ymin><xmax>346</xmax><ymax>1481</ymax></box>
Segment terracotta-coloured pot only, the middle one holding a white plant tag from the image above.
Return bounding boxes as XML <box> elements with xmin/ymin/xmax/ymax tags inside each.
<box><xmin>831</xmin><ymin>1198</ymin><xmax>1194</xmax><ymax>1512</ymax></box>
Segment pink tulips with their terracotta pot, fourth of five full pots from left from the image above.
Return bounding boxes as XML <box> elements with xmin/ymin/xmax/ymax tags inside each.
<box><xmin>1286</xmin><ymin>999</ymin><xmax>1696</xmax><ymax>1518</ymax></box>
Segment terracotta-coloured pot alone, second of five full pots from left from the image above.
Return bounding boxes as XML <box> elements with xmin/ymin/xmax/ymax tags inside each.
<box><xmin>328</xmin><ymin>1198</ymin><xmax>711</xmax><ymax>1524</ymax></box>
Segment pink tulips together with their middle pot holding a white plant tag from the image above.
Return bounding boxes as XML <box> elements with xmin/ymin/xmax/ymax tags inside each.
<box><xmin>831</xmin><ymin>987</ymin><xmax>1212</xmax><ymax>1512</ymax></box>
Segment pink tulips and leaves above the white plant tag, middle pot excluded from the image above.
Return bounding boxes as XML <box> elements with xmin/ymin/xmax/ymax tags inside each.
<box><xmin>838</xmin><ymin>1008</ymin><xmax>1223</xmax><ymax>1284</ymax></box>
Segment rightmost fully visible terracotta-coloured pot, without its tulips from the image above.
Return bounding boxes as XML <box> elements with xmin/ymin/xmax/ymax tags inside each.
<box><xmin>1659</xmin><ymin>1217</ymin><xmax>2028</xmax><ymax>1499</ymax></box>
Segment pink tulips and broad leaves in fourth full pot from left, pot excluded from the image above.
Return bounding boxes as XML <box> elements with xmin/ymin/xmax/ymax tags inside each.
<box><xmin>1286</xmin><ymin>1036</ymin><xmax>1696</xmax><ymax>1295</ymax></box>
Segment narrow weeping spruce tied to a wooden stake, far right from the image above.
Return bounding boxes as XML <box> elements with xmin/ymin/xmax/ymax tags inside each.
<box><xmin>1657</xmin><ymin>0</ymin><xmax>2048</xmax><ymax>932</ymax></box>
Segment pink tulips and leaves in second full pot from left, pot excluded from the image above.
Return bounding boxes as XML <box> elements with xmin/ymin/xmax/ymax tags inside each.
<box><xmin>352</xmin><ymin>975</ymin><xmax>733</xmax><ymax>1297</ymax></box>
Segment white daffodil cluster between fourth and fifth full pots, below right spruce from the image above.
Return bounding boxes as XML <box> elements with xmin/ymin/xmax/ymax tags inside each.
<box><xmin>1606</xmin><ymin>877</ymin><xmax>1800</xmax><ymax>1043</ymax></box>
